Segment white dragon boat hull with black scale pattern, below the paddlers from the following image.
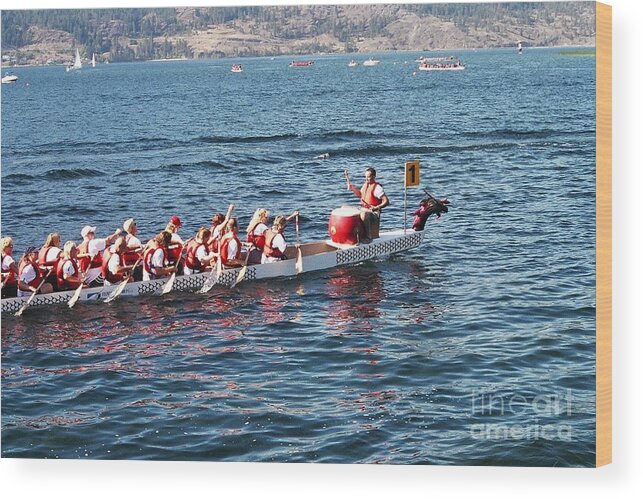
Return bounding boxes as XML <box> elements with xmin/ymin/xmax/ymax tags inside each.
<box><xmin>2</xmin><ymin>229</ymin><xmax>424</xmax><ymax>314</ymax></box>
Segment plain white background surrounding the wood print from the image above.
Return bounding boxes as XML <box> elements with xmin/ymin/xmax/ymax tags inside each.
<box><xmin>0</xmin><ymin>0</ymin><xmax>643</xmax><ymax>499</ymax></box>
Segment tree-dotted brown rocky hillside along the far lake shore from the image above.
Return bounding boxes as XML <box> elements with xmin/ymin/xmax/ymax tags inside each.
<box><xmin>2</xmin><ymin>2</ymin><xmax>595</xmax><ymax>65</ymax></box>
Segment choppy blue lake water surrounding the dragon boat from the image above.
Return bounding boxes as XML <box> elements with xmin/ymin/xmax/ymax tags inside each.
<box><xmin>2</xmin><ymin>49</ymin><xmax>596</xmax><ymax>466</ymax></box>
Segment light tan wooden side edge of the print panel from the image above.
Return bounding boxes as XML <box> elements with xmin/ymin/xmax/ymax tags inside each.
<box><xmin>596</xmin><ymin>2</ymin><xmax>612</xmax><ymax>467</ymax></box>
